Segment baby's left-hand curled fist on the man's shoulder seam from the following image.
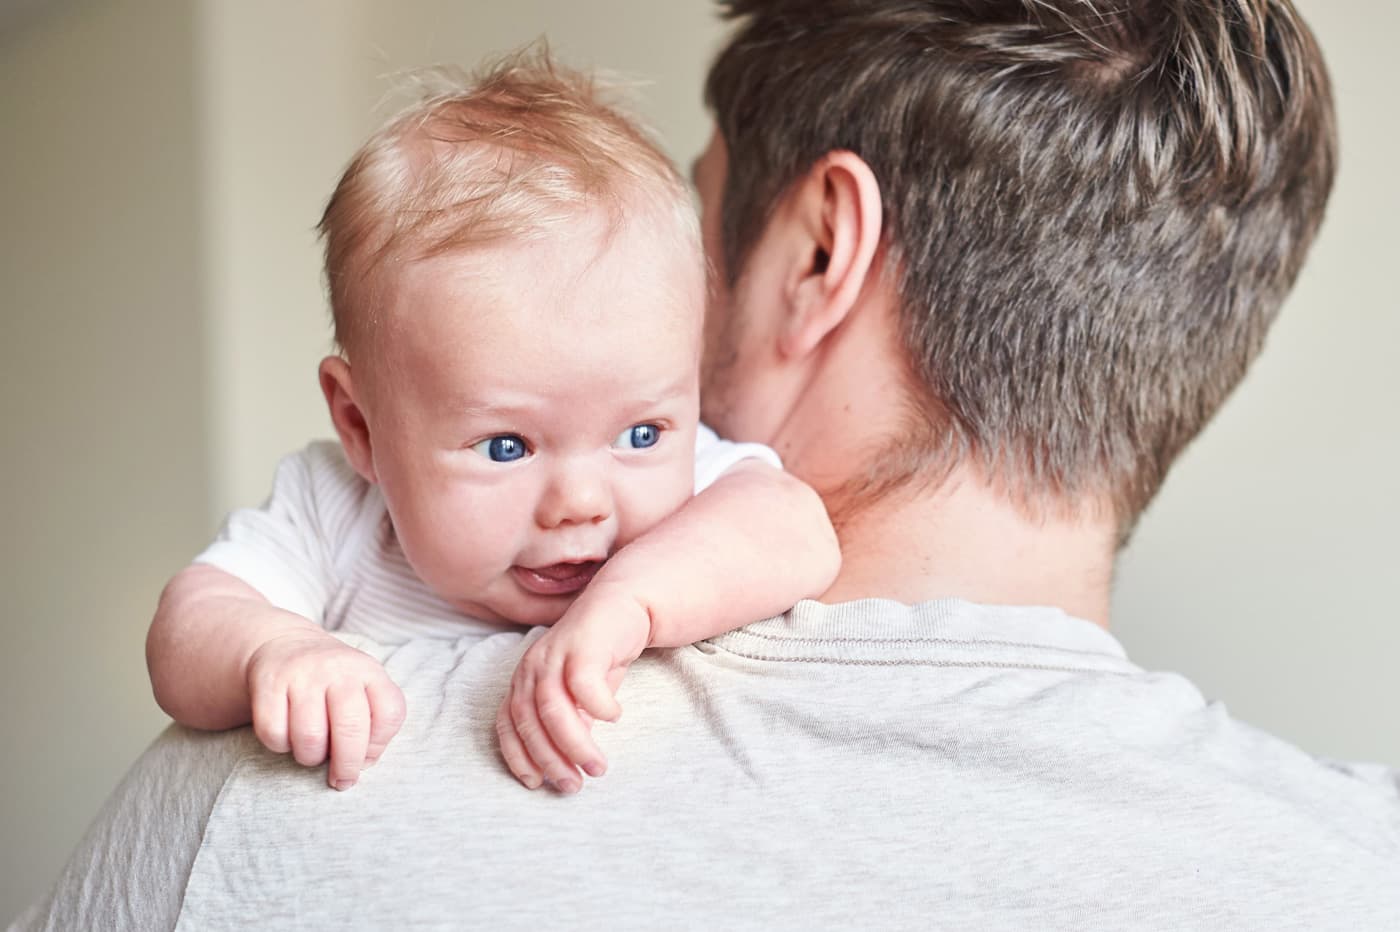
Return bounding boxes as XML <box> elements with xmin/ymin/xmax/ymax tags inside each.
<box><xmin>240</xmin><ymin>631</ymin><xmax>405</xmax><ymax>789</ymax></box>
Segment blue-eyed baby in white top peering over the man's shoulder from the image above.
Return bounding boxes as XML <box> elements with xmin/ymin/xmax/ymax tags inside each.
<box><xmin>147</xmin><ymin>55</ymin><xmax>840</xmax><ymax>792</ymax></box>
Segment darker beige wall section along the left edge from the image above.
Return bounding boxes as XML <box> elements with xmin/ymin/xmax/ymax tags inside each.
<box><xmin>0</xmin><ymin>0</ymin><xmax>210</xmax><ymax>924</ymax></box>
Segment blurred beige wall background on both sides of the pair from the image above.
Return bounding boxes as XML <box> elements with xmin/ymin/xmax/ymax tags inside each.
<box><xmin>0</xmin><ymin>0</ymin><xmax>1400</xmax><ymax>922</ymax></box>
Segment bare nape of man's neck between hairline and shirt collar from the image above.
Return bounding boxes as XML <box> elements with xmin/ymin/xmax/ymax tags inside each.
<box><xmin>822</xmin><ymin>469</ymin><xmax>1113</xmax><ymax>627</ymax></box>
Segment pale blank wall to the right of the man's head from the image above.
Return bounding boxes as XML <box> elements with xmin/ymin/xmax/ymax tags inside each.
<box><xmin>1114</xmin><ymin>0</ymin><xmax>1400</xmax><ymax>765</ymax></box>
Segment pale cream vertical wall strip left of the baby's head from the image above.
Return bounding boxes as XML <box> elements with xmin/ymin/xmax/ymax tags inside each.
<box><xmin>192</xmin><ymin>0</ymin><xmax>368</xmax><ymax>523</ymax></box>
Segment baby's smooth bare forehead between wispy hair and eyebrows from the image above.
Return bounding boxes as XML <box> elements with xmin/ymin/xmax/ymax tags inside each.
<box><xmin>361</xmin><ymin>226</ymin><xmax>704</xmax><ymax>410</ymax></box>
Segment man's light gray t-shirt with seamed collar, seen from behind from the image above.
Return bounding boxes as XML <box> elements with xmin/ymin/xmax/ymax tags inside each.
<box><xmin>20</xmin><ymin>600</ymin><xmax>1400</xmax><ymax>932</ymax></box>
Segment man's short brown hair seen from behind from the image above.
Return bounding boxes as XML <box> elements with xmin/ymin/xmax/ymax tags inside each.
<box><xmin>706</xmin><ymin>0</ymin><xmax>1334</xmax><ymax>533</ymax></box>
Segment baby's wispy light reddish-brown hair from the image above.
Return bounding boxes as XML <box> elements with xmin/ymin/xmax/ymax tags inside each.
<box><xmin>318</xmin><ymin>45</ymin><xmax>701</xmax><ymax>355</ymax></box>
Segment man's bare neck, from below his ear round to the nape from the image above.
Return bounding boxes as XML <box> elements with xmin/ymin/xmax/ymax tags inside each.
<box><xmin>770</xmin><ymin>300</ymin><xmax>1116</xmax><ymax>627</ymax></box>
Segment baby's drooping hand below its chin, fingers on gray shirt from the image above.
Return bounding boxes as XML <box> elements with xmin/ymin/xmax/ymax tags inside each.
<box><xmin>496</xmin><ymin>579</ymin><xmax>651</xmax><ymax>793</ymax></box>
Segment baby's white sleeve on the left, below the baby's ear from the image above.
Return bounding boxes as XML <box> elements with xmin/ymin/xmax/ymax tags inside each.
<box><xmin>195</xmin><ymin>442</ymin><xmax>370</xmax><ymax>624</ymax></box>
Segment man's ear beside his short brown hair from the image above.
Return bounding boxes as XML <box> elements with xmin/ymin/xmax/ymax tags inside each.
<box><xmin>778</xmin><ymin>150</ymin><xmax>883</xmax><ymax>357</ymax></box>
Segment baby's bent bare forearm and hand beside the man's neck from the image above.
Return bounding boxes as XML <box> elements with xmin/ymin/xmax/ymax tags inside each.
<box><xmin>497</xmin><ymin>459</ymin><xmax>840</xmax><ymax>792</ymax></box>
